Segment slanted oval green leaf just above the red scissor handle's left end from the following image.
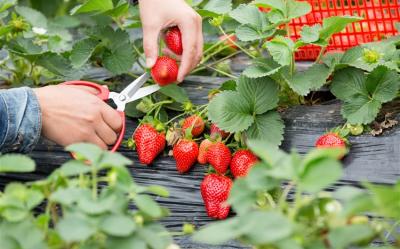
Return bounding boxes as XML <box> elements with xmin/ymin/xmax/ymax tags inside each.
<box><xmin>70</xmin><ymin>38</ymin><xmax>99</xmax><ymax>68</ymax></box>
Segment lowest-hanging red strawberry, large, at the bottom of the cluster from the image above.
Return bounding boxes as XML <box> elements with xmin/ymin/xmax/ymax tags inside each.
<box><xmin>200</xmin><ymin>174</ymin><xmax>232</xmax><ymax>219</ymax></box>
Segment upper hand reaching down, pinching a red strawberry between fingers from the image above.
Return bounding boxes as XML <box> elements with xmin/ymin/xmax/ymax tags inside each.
<box><xmin>139</xmin><ymin>0</ymin><xmax>203</xmax><ymax>82</ymax></box>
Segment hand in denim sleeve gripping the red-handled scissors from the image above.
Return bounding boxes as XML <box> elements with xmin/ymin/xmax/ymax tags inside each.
<box><xmin>34</xmin><ymin>85</ymin><xmax>122</xmax><ymax>149</ymax></box>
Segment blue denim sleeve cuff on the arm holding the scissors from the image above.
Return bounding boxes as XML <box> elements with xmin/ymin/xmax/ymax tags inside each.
<box><xmin>0</xmin><ymin>87</ymin><xmax>42</xmax><ymax>153</ymax></box>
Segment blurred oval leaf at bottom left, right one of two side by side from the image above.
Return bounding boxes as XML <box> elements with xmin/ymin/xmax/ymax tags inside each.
<box><xmin>100</xmin><ymin>214</ymin><xmax>136</xmax><ymax>237</ymax></box>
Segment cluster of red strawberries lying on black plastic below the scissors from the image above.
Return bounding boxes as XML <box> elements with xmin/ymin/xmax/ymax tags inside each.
<box><xmin>134</xmin><ymin>114</ymin><xmax>258</xmax><ymax>219</ymax></box>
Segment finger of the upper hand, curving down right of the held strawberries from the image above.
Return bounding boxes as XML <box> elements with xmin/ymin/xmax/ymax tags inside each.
<box><xmin>178</xmin><ymin>13</ymin><xmax>203</xmax><ymax>82</ymax></box>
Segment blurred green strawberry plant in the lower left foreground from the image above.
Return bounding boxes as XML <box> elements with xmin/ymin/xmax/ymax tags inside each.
<box><xmin>0</xmin><ymin>144</ymin><xmax>172</xmax><ymax>249</ymax></box>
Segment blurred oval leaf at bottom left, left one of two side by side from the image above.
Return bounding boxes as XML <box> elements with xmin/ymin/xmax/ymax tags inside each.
<box><xmin>56</xmin><ymin>215</ymin><xmax>96</xmax><ymax>243</ymax></box>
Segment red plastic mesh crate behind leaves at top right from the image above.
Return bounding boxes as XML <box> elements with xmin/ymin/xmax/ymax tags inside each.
<box><xmin>290</xmin><ymin>0</ymin><xmax>400</xmax><ymax>60</ymax></box>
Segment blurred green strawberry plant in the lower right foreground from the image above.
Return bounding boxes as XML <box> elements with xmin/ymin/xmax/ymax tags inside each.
<box><xmin>193</xmin><ymin>141</ymin><xmax>400</xmax><ymax>249</ymax></box>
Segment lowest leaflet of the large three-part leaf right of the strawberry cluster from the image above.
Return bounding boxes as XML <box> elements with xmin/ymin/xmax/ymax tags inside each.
<box><xmin>246</xmin><ymin>111</ymin><xmax>285</xmax><ymax>145</ymax></box>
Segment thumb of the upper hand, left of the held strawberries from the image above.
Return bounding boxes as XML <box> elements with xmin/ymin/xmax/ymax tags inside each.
<box><xmin>143</xmin><ymin>28</ymin><xmax>160</xmax><ymax>68</ymax></box>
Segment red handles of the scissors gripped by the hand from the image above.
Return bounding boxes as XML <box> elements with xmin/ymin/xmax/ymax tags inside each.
<box><xmin>61</xmin><ymin>80</ymin><xmax>126</xmax><ymax>154</ymax></box>
